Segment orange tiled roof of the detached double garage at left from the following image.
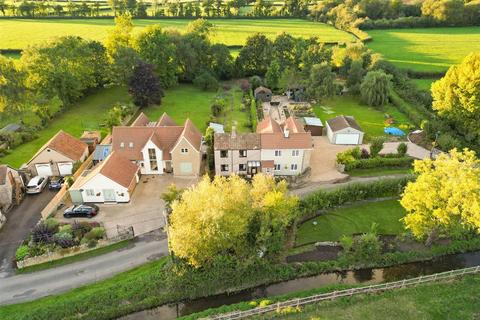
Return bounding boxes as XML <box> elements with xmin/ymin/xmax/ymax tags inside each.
<box><xmin>29</xmin><ymin>130</ymin><xmax>88</xmax><ymax>162</ymax></box>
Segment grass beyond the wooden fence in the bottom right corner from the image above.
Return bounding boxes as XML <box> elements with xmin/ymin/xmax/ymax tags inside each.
<box><xmin>268</xmin><ymin>275</ymin><xmax>480</xmax><ymax>320</ymax></box>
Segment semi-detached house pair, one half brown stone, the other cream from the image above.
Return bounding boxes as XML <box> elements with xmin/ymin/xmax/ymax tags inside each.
<box><xmin>214</xmin><ymin>116</ymin><xmax>313</xmax><ymax>177</ymax></box>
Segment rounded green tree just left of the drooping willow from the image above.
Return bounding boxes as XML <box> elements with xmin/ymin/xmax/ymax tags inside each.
<box><xmin>307</xmin><ymin>63</ymin><xmax>335</xmax><ymax>100</ymax></box>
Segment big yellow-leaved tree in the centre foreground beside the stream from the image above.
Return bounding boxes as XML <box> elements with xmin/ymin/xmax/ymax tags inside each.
<box><xmin>169</xmin><ymin>174</ymin><xmax>298</xmax><ymax>267</ymax></box>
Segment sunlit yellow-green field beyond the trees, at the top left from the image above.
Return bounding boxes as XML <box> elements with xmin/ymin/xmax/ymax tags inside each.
<box><xmin>0</xmin><ymin>19</ymin><xmax>354</xmax><ymax>49</ymax></box>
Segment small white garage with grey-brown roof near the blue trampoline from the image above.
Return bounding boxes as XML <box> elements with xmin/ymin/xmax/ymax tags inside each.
<box><xmin>327</xmin><ymin>116</ymin><xmax>364</xmax><ymax>145</ymax></box>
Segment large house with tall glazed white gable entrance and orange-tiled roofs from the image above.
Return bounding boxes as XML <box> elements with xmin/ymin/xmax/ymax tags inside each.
<box><xmin>112</xmin><ymin>113</ymin><xmax>202</xmax><ymax>176</ymax></box>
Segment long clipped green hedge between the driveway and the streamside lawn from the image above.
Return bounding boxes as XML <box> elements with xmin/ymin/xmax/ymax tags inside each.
<box><xmin>299</xmin><ymin>176</ymin><xmax>414</xmax><ymax>220</ymax></box>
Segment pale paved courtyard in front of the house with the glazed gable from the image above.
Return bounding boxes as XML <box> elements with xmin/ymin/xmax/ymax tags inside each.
<box><xmin>56</xmin><ymin>175</ymin><xmax>198</xmax><ymax>237</ymax></box>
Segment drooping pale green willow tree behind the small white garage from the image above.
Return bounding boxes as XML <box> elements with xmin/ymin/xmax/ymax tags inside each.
<box><xmin>360</xmin><ymin>70</ymin><xmax>392</xmax><ymax>107</ymax></box>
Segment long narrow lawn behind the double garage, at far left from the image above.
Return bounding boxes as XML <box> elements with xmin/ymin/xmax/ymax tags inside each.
<box><xmin>0</xmin><ymin>87</ymin><xmax>130</xmax><ymax>168</ymax></box>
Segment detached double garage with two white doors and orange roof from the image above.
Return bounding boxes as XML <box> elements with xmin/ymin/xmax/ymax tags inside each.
<box><xmin>27</xmin><ymin>130</ymin><xmax>88</xmax><ymax>176</ymax></box>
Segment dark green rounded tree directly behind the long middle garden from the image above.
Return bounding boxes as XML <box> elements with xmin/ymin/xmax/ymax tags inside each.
<box><xmin>235</xmin><ymin>33</ymin><xmax>273</xmax><ymax>76</ymax></box>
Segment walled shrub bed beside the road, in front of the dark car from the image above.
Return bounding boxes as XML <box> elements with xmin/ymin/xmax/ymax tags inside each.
<box><xmin>15</xmin><ymin>218</ymin><xmax>106</xmax><ymax>269</ymax></box>
